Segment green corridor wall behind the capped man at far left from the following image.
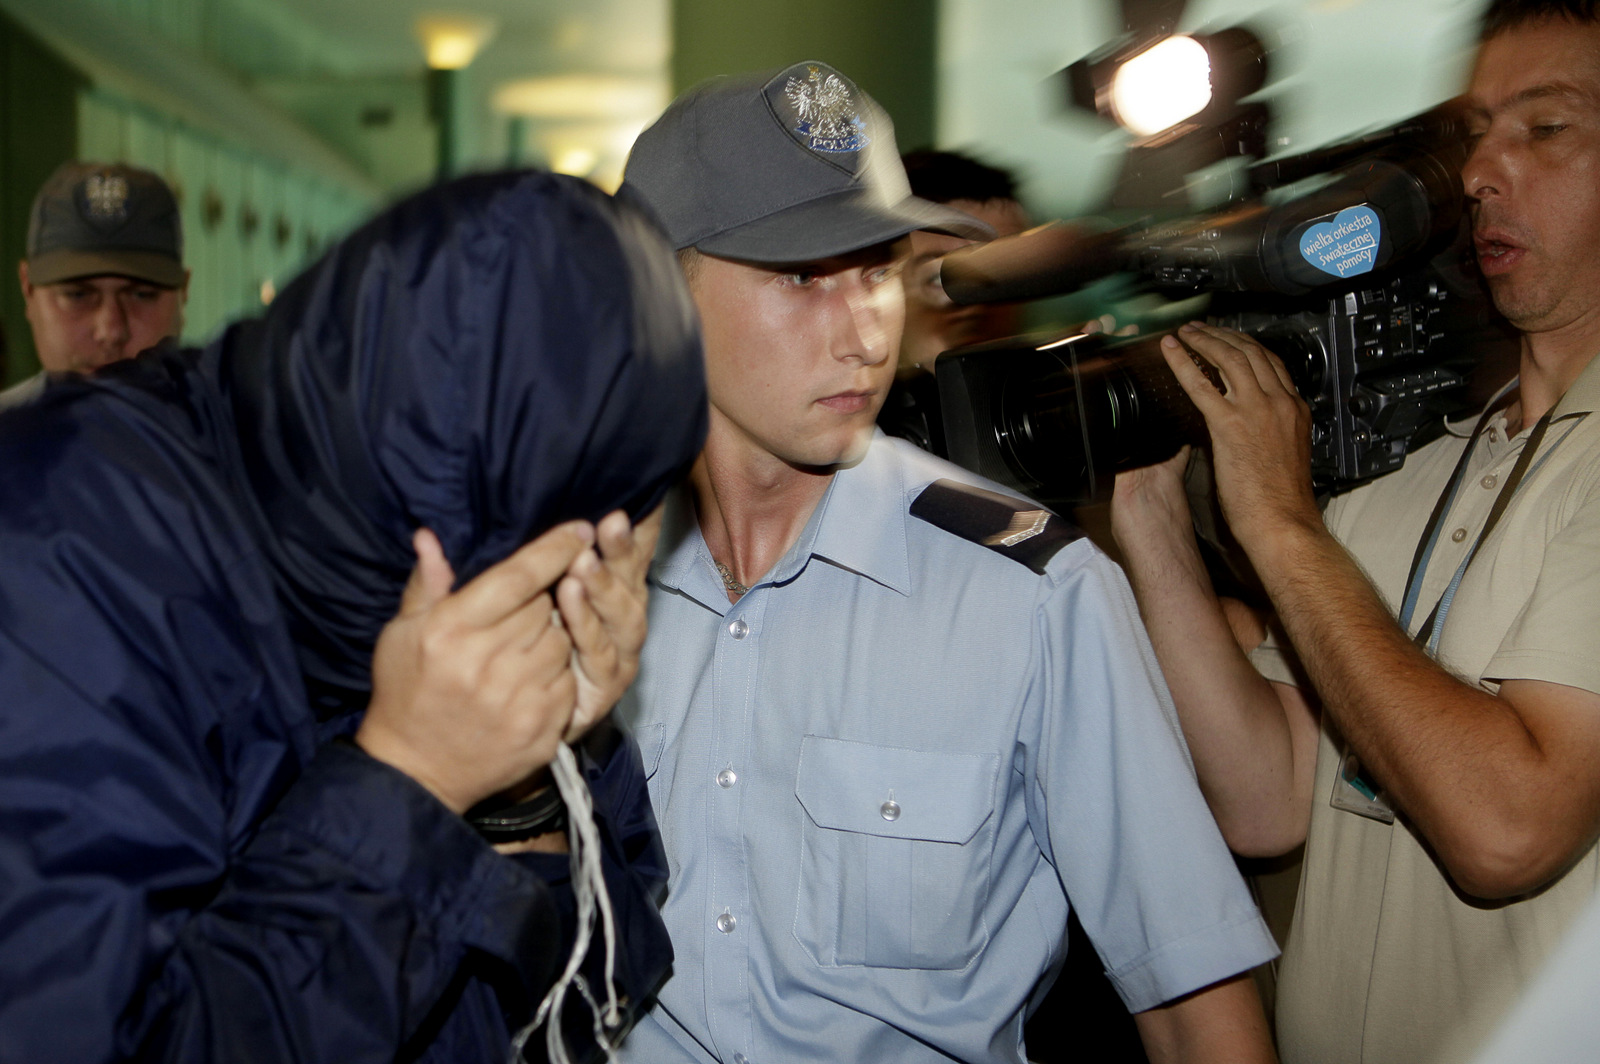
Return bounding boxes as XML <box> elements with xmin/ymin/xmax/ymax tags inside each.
<box><xmin>0</xmin><ymin>0</ymin><xmax>382</xmax><ymax>382</ymax></box>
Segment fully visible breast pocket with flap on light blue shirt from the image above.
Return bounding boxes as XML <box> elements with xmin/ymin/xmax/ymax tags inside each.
<box><xmin>794</xmin><ymin>736</ymin><xmax>1000</xmax><ymax>970</ymax></box>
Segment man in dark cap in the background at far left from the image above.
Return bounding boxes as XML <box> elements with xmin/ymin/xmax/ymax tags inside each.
<box><xmin>18</xmin><ymin>163</ymin><xmax>189</xmax><ymax>373</ymax></box>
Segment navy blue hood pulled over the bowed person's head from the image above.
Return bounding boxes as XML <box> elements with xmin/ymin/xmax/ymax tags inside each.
<box><xmin>212</xmin><ymin>173</ymin><xmax>707</xmax><ymax>691</ymax></box>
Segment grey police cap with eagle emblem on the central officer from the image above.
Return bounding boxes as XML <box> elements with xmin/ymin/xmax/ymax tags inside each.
<box><xmin>621</xmin><ymin>62</ymin><xmax>994</xmax><ymax>264</ymax></box>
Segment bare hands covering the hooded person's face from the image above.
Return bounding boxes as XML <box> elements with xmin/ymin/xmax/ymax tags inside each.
<box><xmin>355</xmin><ymin>509</ymin><xmax>661</xmax><ymax>813</ymax></box>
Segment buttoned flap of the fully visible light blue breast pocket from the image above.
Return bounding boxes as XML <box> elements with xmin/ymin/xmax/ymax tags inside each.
<box><xmin>795</xmin><ymin>736</ymin><xmax>1000</xmax><ymax>843</ymax></box>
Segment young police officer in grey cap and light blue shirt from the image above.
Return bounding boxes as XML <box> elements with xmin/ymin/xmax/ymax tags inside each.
<box><xmin>618</xmin><ymin>62</ymin><xmax>1274</xmax><ymax>1064</ymax></box>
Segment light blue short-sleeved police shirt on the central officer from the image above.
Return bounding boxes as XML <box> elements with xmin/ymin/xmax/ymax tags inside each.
<box><xmin>618</xmin><ymin>434</ymin><xmax>1277</xmax><ymax>1064</ymax></box>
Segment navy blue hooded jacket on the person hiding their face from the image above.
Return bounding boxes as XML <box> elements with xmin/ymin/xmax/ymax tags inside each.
<box><xmin>0</xmin><ymin>174</ymin><xmax>706</xmax><ymax>1064</ymax></box>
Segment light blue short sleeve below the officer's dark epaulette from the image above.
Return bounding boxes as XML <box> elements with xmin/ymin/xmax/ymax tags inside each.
<box><xmin>1037</xmin><ymin>554</ymin><xmax>1277</xmax><ymax>1011</ymax></box>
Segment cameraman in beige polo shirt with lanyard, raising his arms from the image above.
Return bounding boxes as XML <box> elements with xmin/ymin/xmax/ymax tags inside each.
<box><xmin>1112</xmin><ymin>0</ymin><xmax>1600</xmax><ymax>1064</ymax></box>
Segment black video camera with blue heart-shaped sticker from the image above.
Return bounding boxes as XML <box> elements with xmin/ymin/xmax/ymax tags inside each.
<box><xmin>936</xmin><ymin>109</ymin><xmax>1490</xmax><ymax>504</ymax></box>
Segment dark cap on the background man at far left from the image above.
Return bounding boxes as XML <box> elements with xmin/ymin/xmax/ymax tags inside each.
<box><xmin>27</xmin><ymin>163</ymin><xmax>184</xmax><ymax>288</ymax></box>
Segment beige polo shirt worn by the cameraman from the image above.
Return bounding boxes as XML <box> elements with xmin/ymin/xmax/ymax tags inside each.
<box><xmin>1253</xmin><ymin>358</ymin><xmax>1600</xmax><ymax>1064</ymax></box>
